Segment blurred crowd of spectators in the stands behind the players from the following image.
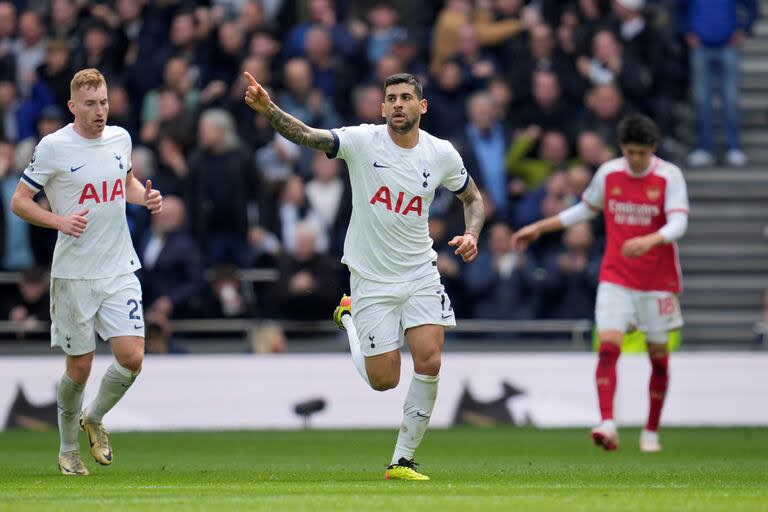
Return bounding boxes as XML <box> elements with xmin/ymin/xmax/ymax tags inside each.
<box><xmin>0</xmin><ymin>0</ymin><xmax>756</xmax><ymax>348</ymax></box>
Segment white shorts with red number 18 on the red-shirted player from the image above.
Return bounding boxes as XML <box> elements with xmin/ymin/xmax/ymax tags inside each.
<box><xmin>595</xmin><ymin>283</ymin><xmax>683</xmax><ymax>343</ymax></box>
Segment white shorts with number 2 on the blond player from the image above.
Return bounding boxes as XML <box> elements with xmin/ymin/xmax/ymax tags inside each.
<box><xmin>51</xmin><ymin>274</ymin><xmax>144</xmax><ymax>356</ymax></box>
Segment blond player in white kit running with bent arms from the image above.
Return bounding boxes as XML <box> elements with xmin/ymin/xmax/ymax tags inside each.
<box><xmin>11</xmin><ymin>69</ymin><xmax>162</xmax><ymax>475</ymax></box>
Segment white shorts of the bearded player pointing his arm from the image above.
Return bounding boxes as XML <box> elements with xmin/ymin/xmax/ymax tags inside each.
<box><xmin>350</xmin><ymin>269</ymin><xmax>456</xmax><ymax>357</ymax></box>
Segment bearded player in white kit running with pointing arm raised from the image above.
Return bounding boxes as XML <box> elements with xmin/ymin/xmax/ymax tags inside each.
<box><xmin>245</xmin><ymin>73</ymin><xmax>485</xmax><ymax>480</ymax></box>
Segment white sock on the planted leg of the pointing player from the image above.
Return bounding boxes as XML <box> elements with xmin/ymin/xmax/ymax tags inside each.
<box><xmin>392</xmin><ymin>373</ymin><xmax>440</xmax><ymax>464</ymax></box>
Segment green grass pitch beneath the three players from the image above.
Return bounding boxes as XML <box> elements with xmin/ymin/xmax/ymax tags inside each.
<box><xmin>0</xmin><ymin>428</ymin><xmax>768</xmax><ymax>512</ymax></box>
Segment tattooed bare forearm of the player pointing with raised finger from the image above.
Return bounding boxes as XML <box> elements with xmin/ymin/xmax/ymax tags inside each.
<box><xmin>245</xmin><ymin>72</ymin><xmax>335</xmax><ymax>153</ymax></box>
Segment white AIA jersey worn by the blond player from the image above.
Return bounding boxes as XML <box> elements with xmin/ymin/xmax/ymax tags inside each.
<box><xmin>21</xmin><ymin>123</ymin><xmax>141</xmax><ymax>279</ymax></box>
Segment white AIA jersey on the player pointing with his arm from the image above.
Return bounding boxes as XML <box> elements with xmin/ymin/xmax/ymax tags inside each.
<box><xmin>330</xmin><ymin>124</ymin><xmax>469</xmax><ymax>282</ymax></box>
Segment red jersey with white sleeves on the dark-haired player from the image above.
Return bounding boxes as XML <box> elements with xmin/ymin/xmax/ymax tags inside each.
<box><xmin>582</xmin><ymin>156</ymin><xmax>688</xmax><ymax>293</ymax></box>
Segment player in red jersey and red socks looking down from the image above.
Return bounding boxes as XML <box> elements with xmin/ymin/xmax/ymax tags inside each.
<box><xmin>513</xmin><ymin>114</ymin><xmax>688</xmax><ymax>452</ymax></box>
